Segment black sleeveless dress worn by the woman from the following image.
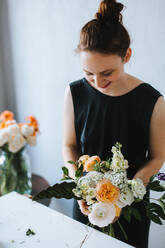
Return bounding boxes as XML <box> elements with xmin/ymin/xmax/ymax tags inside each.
<box><xmin>70</xmin><ymin>78</ymin><xmax>161</xmax><ymax>248</ymax></box>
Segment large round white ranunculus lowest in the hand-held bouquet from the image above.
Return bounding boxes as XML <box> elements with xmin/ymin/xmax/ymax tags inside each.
<box><xmin>88</xmin><ymin>202</ymin><xmax>116</xmax><ymax>227</ymax></box>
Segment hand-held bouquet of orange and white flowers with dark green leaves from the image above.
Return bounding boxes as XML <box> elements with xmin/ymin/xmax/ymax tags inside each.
<box><xmin>33</xmin><ymin>143</ymin><xmax>165</xmax><ymax>239</ymax></box>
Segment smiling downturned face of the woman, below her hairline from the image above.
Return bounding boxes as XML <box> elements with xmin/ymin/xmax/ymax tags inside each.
<box><xmin>80</xmin><ymin>51</ymin><xmax>130</xmax><ymax>93</ymax></box>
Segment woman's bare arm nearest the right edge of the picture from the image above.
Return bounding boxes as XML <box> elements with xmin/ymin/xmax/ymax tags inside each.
<box><xmin>134</xmin><ymin>97</ymin><xmax>165</xmax><ymax>184</ymax></box>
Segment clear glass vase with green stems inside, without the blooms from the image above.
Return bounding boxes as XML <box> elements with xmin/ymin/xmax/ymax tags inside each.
<box><xmin>0</xmin><ymin>149</ymin><xmax>32</xmax><ymax>195</ymax></box>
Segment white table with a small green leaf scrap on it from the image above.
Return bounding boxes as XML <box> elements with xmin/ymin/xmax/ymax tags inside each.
<box><xmin>0</xmin><ymin>192</ymin><xmax>132</xmax><ymax>248</ymax></box>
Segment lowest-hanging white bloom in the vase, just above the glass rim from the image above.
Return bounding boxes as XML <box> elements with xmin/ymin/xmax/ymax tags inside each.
<box><xmin>8</xmin><ymin>133</ymin><xmax>26</xmax><ymax>153</ymax></box>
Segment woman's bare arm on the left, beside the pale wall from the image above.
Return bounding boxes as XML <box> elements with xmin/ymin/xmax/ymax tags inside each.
<box><xmin>62</xmin><ymin>86</ymin><xmax>79</xmax><ymax>178</ymax></box>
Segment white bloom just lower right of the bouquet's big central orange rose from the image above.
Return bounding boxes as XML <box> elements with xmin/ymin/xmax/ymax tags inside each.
<box><xmin>116</xmin><ymin>187</ymin><xmax>134</xmax><ymax>208</ymax></box>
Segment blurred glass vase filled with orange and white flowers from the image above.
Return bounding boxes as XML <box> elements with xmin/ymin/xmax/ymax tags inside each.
<box><xmin>0</xmin><ymin>111</ymin><xmax>39</xmax><ymax>195</ymax></box>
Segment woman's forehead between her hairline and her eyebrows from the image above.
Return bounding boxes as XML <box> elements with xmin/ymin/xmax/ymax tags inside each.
<box><xmin>80</xmin><ymin>51</ymin><xmax>122</xmax><ymax>73</ymax></box>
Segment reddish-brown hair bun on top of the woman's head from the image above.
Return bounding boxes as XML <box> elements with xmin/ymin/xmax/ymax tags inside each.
<box><xmin>95</xmin><ymin>0</ymin><xmax>124</xmax><ymax>23</ymax></box>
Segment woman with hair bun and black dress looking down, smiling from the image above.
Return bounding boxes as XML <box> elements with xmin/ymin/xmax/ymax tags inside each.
<box><xmin>63</xmin><ymin>0</ymin><xmax>165</xmax><ymax>248</ymax></box>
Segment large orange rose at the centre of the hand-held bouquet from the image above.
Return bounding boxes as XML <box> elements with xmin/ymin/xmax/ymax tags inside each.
<box><xmin>96</xmin><ymin>179</ymin><xmax>120</xmax><ymax>203</ymax></box>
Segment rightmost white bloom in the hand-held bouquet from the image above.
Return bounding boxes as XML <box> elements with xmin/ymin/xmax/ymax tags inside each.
<box><xmin>128</xmin><ymin>178</ymin><xmax>146</xmax><ymax>200</ymax></box>
